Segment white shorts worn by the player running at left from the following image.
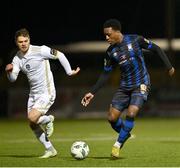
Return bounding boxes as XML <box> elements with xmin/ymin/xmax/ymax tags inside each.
<box><xmin>27</xmin><ymin>94</ymin><xmax>56</xmax><ymax>114</ymax></box>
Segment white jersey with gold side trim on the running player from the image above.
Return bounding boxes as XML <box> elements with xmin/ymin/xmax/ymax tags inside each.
<box><xmin>12</xmin><ymin>45</ymin><xmax>67</xmax><ymax>95</ymax></box>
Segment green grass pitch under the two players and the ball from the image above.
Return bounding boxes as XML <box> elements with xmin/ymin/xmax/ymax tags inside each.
<box><xmin>0</xmin><ymin>118</ymin><xmax>180</xmax><ymax>167</ymax></box>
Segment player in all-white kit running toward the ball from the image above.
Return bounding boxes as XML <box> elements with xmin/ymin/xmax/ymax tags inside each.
<box><xmin>5</xmin><ymin>28</ymin><xmax>80</xmax><ymax>158</ymax></box>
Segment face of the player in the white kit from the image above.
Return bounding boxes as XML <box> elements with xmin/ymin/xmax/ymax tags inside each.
<box><xmin>16</xmin><ymin>36</ymin><xmax>30</xmax><ymax>54</ymax></box>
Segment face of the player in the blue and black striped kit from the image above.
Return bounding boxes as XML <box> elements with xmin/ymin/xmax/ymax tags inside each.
<box><xmin>104</xmin><ymin>27</ymin><xmax>121</xmax><ymax>45</ymax></box>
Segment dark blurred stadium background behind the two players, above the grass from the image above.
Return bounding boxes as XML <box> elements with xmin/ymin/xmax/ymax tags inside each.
<box><xmin>0</xmin><ymin>0</ymin><xmax>180</xmax><ymax>118</ymax></box>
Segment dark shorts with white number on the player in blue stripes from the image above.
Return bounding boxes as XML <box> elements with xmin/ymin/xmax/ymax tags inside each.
<box><xmin>112</xmin><ymin>85</ymin><xmax>150</xmax><ymax>112</ymax></box>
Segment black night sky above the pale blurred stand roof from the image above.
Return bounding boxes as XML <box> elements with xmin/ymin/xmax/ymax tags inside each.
<box><xmin>1</xmin><ymin>0</ymin><xmax>180</xmax><ymax>64</ymax></box>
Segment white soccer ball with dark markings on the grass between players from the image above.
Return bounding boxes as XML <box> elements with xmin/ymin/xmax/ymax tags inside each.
<box><xmin>71</xmin><ymin>141</ymin><xmax>89</xmax><ymax>160</ymax></box>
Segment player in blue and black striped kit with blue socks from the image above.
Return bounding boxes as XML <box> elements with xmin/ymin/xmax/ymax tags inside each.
<box><xmin>81</xmin><ymin>19</ymin><xmax>175</xmax><ymax>159</ymax></box>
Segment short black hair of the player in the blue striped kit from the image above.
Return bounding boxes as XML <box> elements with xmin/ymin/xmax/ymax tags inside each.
<box><xmin>103</xmin><ymin>19</ymin><xmax>121</xmax><ymax>31</ymax></box>
